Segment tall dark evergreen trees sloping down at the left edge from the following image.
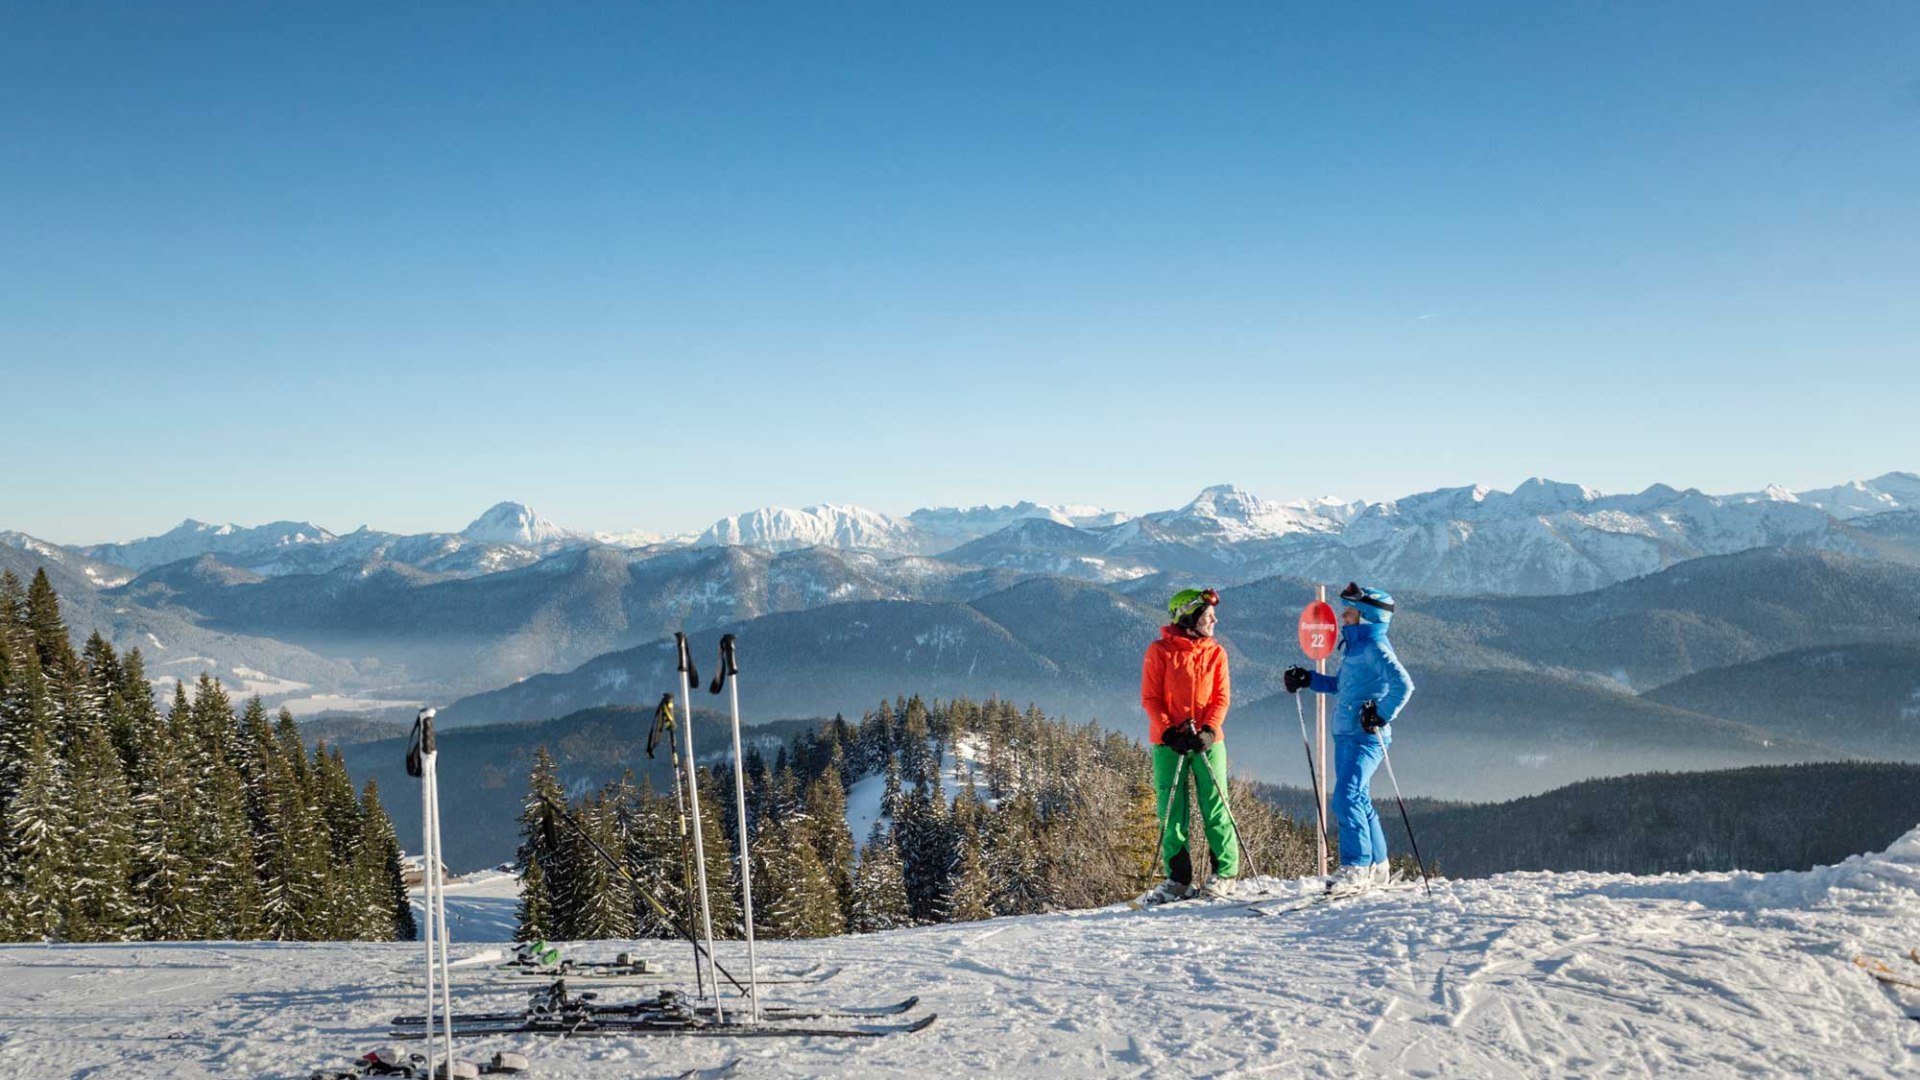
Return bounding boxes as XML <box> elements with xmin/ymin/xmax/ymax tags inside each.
<box><xmin>0</xmin><ymin>571</ymin><xmax>417</xmax><ymax>942</ymax></box>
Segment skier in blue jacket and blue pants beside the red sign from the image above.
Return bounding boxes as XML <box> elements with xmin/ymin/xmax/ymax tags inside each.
<box><xmin>1284</xmin><ymin>582</ymin><xmax>1413</xmax><ymax>892</ymax></box>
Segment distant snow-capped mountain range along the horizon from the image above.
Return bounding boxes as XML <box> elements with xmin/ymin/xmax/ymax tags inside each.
<box><xmin>15</xmin><ymin>473</ymin><xmax>1920</xmax><ymax>594</ymax></box>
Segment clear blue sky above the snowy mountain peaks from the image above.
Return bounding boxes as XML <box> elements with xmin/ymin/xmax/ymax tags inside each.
<box><xmin>0</xmin><ymin>0</ymin><xmax>1920</xmax><ymax>542</ymax></box>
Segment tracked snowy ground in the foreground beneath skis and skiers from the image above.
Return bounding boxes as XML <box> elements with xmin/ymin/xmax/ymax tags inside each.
<box><xmin>0</xmin><ymin>828</ymin><xmax>1920</xmax><ymax>1078</ymax></box>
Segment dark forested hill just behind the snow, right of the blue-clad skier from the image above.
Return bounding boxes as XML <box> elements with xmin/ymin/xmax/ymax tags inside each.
<box><xmin>1413</xmin><ymin>763</ymin><xmax>1920</xmax><ymax>878</ymax></box>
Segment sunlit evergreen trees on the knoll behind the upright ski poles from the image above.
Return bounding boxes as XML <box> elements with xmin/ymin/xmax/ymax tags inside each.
<box><xmin>518</xmin><ymin>698</ymin><xmax>1313</xmax><ymax>940</ymax></box>
